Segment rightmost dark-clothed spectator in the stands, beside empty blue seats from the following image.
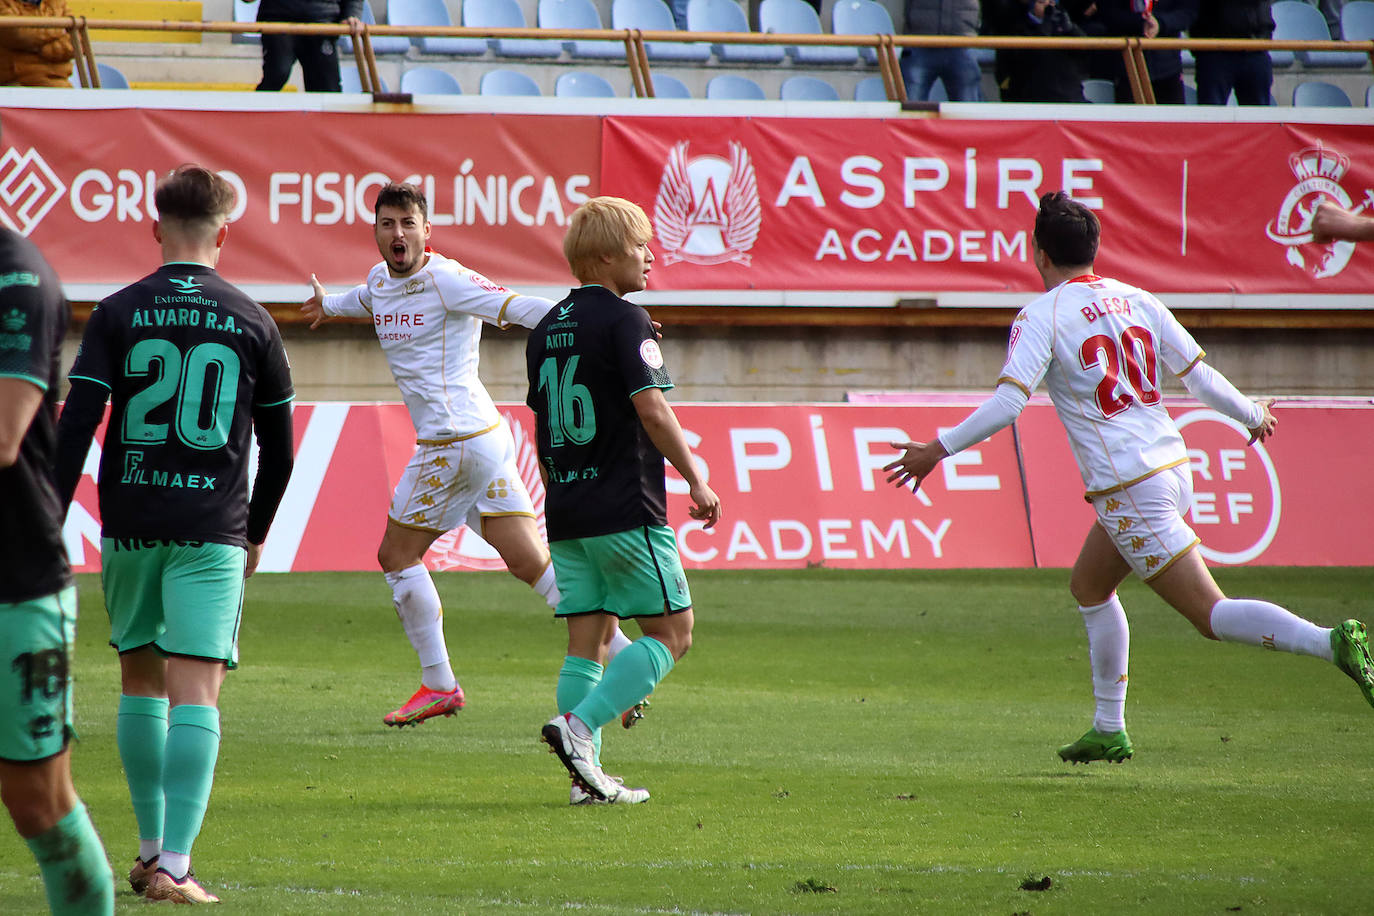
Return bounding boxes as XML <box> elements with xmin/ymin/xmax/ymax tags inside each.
<box><xmin>1189</xmin><ymin>0</ymin><xmax>1274</xmax><ymax>104</ymax></box>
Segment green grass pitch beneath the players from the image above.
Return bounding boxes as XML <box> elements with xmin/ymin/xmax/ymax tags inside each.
<box><xmin>0</xmin><ymin>569</ymin><xmax>1374</xmax><ymax>916</ymax></box>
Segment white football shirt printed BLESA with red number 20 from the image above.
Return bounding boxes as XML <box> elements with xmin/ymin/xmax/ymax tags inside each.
<box><xmin>998</xmin><ymin>275</ymin><xmax>1204</xmax><ymax>496</ymax></box>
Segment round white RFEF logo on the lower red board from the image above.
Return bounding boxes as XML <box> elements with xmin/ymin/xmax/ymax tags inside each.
<box><xmin>1173</xmin><ymin>409</ymin><xmax>1283</xmax><ymax>564</ymax></box>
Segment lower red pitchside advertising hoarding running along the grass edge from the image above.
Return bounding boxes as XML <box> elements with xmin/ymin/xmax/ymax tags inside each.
<box><xmin>65</xmin><ymin>396</ymin><xmax>1374</xmax><ymax>571</ymax></box>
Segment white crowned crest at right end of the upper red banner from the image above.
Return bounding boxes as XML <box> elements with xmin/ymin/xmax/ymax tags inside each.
<box><xmin>1264</xmin><ymin>147</ymin><xmax>1374</xmax><ymax>280</ymax></box>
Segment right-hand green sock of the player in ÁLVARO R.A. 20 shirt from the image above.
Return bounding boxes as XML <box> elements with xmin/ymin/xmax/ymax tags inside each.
<box><xmin>162</xmin><ymin>703</ymin><xmax>220</xmax><ymax>856</ymax></box>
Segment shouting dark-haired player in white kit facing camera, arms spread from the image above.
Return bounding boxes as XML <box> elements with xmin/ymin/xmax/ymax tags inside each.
<box><xmin>301</xmin><ymin>183</ymin><xmax>629</xmax><ymax>726</ymax></box>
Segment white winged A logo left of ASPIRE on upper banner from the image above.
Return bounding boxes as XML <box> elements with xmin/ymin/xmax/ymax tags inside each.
<box><xmin>654</xmin><ymin>140</ymin><xmax>763</xmax><ymax>265</ymax></box>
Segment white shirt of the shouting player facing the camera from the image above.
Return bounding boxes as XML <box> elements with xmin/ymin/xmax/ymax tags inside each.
<box><xmin>323</xmin><ymin>249</ymin><xmax>554</xmax><ymax>444</ymax></box>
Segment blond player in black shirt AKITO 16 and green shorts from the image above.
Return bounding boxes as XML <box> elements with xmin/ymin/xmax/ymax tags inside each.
<box><xmin>525</xmin><ymin>198</ymin><xmax>720</xmax><ymax>805</ymax></box>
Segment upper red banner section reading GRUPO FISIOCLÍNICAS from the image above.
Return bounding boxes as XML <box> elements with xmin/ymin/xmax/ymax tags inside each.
<box><xmin>0</xmin><ymin>108</ymin><xmax>600</xmax><ymax>292</ymax></box>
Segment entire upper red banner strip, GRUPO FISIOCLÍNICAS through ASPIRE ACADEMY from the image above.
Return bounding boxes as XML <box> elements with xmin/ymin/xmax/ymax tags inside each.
<box><xmin>0</xmin><ymin>106</ymin><xmax>1374</xmax><ymax>298</ymax></box>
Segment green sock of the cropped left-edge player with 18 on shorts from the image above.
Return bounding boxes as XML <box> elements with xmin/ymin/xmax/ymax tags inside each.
<box><xmin>25</xmin><ymin>801</ymin><xmax>114</xmax><ymax>916</ymax></box>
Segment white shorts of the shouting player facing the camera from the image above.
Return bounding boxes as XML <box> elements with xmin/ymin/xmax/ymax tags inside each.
<box><xmin>387</xmin><ymin>420</ymin><xmax>534</xmax><ymax>534</ymax></box>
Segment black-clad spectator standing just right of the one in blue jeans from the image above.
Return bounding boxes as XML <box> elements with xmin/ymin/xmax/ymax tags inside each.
<box><xmin>982</xmin><ymin>0</ymin><xmax>1087</xmax><ymax>103</ymax></box>
